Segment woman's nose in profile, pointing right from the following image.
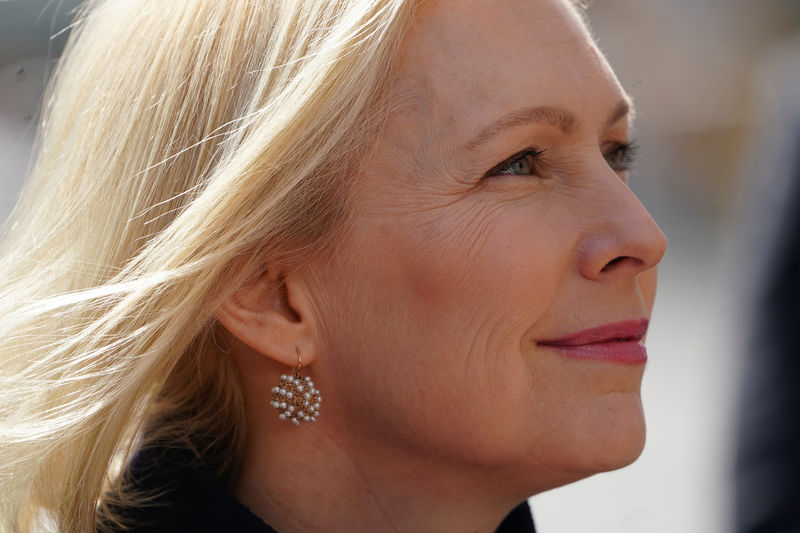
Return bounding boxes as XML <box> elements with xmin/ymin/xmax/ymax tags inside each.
<box><xmin>578</xmin><ymin>175</ymin><xmax>667</xmax><ymax>281</ymax></box>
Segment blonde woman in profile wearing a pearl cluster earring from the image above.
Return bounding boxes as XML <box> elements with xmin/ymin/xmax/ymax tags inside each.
<box><xmin>0</xmin><ymin>0</ymin><xmax>665</xmax><ymax>532</ymax></box>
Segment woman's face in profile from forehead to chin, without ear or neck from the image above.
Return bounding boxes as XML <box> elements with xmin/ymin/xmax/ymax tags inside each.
<box><xmin>304</xmin><ymin>0</ymin><xmax>666</xmax><ymax>489</ymax></box>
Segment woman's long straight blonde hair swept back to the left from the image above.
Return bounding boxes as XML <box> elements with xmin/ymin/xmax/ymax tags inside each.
<box><xmin>0</xmin><ymin>0</ymin><xmax>412</xmax><ymax>531</ymax></box>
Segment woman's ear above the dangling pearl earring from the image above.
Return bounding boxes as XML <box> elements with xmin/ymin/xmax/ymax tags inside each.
<box><xmin>216</xmin><ymin>272</ymin><xmax>317</xmax><ymax>367</ymax></box>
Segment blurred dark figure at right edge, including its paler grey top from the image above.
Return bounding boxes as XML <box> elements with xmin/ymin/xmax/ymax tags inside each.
<box><xmin>733</xmin><ymin>55</ymin><xmax>800</xmax><ymax>533</ymax></box>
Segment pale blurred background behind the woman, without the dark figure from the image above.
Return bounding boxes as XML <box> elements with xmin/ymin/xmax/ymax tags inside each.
<box><xmin>0</xmin><ymin>0</ymin><xmax>800</xmax><ymax>533</ymax></box>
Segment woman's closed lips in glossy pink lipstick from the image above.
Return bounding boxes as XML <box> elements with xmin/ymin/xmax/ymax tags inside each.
<box><xmin>538</xmin><ymin>318</ymin><xmax>649</xmax><ymax>365</ymax></box>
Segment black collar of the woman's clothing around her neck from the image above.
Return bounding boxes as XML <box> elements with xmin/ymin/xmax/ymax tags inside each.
<box><xmin>101</xmin><ymin>444</ymin><xmax>536</xmax><ymax>533</ymax></box>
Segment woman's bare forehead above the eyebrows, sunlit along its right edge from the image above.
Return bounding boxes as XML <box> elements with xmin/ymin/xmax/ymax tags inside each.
<box><xmin>398</xmin><ymin>0</ymin><xmax>624</xmax><ymax>140</ymax></box>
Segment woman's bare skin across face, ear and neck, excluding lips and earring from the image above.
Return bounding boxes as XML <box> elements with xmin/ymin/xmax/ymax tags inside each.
<box><xmin>218</xmin><ymin>0</ymin><xmax>666</xmax><ymax>532</ymax></box>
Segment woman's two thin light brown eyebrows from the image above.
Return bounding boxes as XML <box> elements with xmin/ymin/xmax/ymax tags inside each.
<box><xmin>466</xmin><ymin>98</ymin><xmax>633</xmax><ymax>150</ymax></box>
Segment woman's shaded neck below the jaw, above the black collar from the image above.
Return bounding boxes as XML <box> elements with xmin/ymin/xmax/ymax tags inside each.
<box><xmin>232</xmin><ymin>411</ymin><xmax>524</xmax><ymax>533</ymax></box>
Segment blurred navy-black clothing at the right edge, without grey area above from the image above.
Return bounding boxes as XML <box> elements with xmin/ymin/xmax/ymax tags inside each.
<box><xmin>734</xmin><ymin>134</ymin><xmax>800</xmax><ymax>533</ymax></box>
